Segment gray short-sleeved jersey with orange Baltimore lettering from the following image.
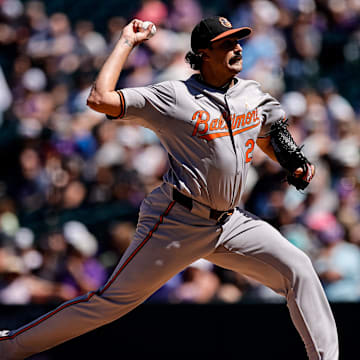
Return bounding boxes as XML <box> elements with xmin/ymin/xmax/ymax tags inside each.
<box><xmin>120</xmin><ymin>75</ymin><xmax>285</xmax><ymax>210</ymax></box>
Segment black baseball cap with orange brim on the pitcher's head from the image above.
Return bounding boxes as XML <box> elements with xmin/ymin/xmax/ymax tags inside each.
<box><xmin>191</xmin><ymin>16</ymin><xmax>252</xmax><ymax>52</ymax></box>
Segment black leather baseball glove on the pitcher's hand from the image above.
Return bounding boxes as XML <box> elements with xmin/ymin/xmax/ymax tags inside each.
<box><xmin>270</xmin><ymin>120</ymin><xmax>315</xmax><ymax>190</ymax></box>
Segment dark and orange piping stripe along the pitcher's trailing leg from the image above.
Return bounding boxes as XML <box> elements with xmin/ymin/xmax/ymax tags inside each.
<box><xmin>0</xmin><ymin>201</ymin><xmax>175</xmax><ymax>341</ymax></box>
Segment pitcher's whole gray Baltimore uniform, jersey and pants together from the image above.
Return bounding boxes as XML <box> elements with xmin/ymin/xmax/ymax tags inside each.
<box><xmin>0</xmin><ymin>75</ymin><xmax>338</xmax><ymax>360</ymax></box>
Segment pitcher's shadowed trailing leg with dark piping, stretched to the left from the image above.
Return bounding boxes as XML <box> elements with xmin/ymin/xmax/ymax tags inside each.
<box><xmin>0</xmin><ymin>190</ymin><xmax>219</xmax><ymax>360</ymax></box>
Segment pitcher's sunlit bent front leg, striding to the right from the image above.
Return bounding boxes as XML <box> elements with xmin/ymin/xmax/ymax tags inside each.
<box><xmin>207</xmin><ymin>210</ymin><xmax>339</xmax><ymax>360</ymax></box>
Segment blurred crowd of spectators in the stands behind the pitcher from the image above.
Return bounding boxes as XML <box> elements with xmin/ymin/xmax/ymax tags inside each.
<box><xmin>0</xmin><ymin>0</ymin><xmax>360</xmax><ymax>304</ymax></box>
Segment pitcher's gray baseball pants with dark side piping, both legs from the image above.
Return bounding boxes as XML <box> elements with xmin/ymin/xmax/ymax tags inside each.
<box><xmin>0</xmin><ymin>184</ymin><xmax>338</xmax><ymax>360</ymax></box>
